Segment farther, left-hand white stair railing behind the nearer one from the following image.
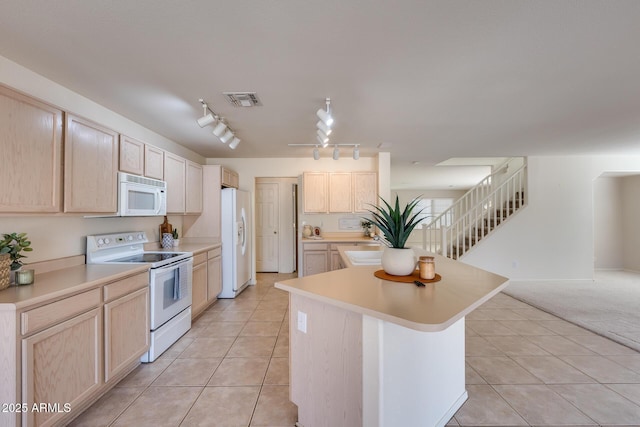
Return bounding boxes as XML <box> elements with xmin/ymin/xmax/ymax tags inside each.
<box><xmin>422</xmin><ymin>157</ymin><xmax>513</xmax><ymax>252</ymax></box>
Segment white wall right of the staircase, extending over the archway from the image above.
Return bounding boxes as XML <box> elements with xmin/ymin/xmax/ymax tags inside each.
<box><xmin>462</xmin><ymin>156</ymin><xmax>640</xmax><ymax>280</ymax></box>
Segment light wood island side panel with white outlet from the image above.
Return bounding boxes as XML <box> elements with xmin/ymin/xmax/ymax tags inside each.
<box><xmin>289</xmin><ymin>294</ymin><xmax>363</xmax><ymax>427</ymax></box>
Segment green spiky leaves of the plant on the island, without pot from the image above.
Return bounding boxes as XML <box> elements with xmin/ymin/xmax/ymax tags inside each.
<box><xmin>367</xmin><ymin>196</ymin><xmax>423</xmax><ymax>249</ymax></box>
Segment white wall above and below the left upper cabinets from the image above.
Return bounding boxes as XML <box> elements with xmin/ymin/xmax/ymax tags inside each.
<box><xmin>0</xmin><ymin>56</ymin><xmax>200</xmax><ymax>263</ymax></box>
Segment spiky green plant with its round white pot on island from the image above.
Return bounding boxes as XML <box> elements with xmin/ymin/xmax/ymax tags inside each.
<box><xmin>368</xmin><ymin>196</ymin><xmax>422</xmax><ymax>276</ymax></box>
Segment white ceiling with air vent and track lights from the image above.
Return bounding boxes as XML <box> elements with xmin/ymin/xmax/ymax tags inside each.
<box><xmin>0</xmin><ymin>0</ymin><xmax>640</xmax><ymax>186</ymax></box>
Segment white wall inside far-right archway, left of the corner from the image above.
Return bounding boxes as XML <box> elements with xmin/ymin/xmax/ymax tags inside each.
<box><xmin>593</xmin><ymin>176</ymin><xmax>624</xmax><ymax>270</ymax></box>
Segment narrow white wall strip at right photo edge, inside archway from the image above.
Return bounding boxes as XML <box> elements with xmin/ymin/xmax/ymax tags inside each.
<box><xmin>622</xmin><ymin>176</ymin><xmax>640</xmax><ymax>272</ymax></box>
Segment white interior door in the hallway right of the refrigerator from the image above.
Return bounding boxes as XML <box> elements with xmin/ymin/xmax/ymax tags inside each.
<box><xmin>256</xmin><ymin>183</ymin><xmax>280</xmax><ymax>272</ymax></box>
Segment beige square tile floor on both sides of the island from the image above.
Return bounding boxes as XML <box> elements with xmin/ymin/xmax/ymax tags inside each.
<box><xmin>72</xmin><ymin>274</ymin><xmax>640</xmax><ymax>427</ymax></box>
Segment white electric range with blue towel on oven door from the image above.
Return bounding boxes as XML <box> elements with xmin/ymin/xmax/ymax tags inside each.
<box><xmin>87</xmin><ymin>231</ymin><xmax>193</xmax><ymax>362</ymax></box>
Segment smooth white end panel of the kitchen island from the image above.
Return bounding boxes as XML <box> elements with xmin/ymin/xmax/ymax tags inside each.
<box><xmin>378</xmin><ymin>317</ymin><xmax>467</xmax><ymax>427</ymax></box>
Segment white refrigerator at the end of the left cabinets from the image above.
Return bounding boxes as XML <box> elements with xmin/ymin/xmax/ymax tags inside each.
<box><xmin>218</xmin><ymin>188</ymin><xmax>251</xmax><ymax>298</ymax></box>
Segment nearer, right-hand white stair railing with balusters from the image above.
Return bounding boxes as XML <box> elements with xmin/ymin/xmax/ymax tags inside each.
<box><xmin>440</xmin><ymin>163</ymin><xmax>527</xmax><ymax>259</ymax></box>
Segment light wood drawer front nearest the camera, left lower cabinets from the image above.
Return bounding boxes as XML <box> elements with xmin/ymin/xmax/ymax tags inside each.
<box><xmin>22</xmin><ymin>289</ymin><xmax>100</xmax><ymax>335</ymax></box>
